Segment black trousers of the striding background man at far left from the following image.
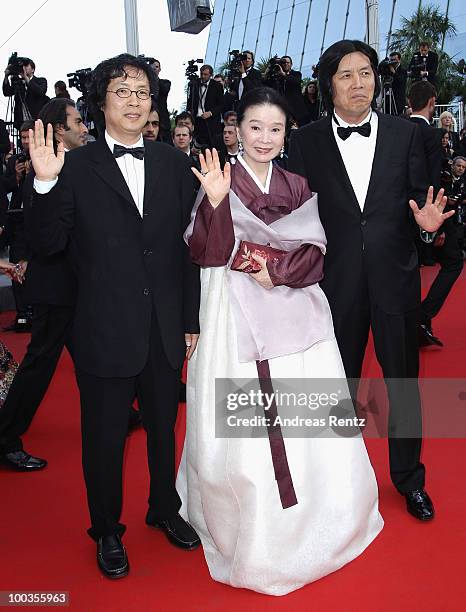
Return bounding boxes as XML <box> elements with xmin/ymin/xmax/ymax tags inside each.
<box><xmin>0</xmin><ymin>304</ymin><xmax>74</xmax><ymax>453</ymax></box>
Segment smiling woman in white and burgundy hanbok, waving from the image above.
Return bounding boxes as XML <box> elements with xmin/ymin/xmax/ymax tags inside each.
<box><xmin>177</xmin><ymin>88</ymin><xmax>383</xmax><ymax>595</ymax></box>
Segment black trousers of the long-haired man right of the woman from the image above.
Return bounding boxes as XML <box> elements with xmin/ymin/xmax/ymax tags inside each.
<box><xmin>333</xmin><ymin>288</ymin><xmax>425</xmax><ymax>493</ymax></box>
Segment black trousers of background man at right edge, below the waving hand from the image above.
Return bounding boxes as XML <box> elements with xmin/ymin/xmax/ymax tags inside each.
<box><xmin>421</xmin><ymin>219</ymin><xmax>464</xmax><ymax>324</ymax></box>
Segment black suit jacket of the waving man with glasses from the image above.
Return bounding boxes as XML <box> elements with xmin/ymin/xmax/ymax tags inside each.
<box><xmin>33</xmin><ymin>138</ymin><xmax>200</xmax><ymax>377</ymax></box>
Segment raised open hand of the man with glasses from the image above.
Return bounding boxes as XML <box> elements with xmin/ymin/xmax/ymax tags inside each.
<box><xmin>29</xmin><ymin>119</ymin><xmax>65</xmax><ymax>181</ymax></box>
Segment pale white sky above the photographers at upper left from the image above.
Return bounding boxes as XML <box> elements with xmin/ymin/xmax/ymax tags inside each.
<box><xmin>0</xmin><ymin>0</ymin><xmax>209</xmax><ymax>119</ymax></box>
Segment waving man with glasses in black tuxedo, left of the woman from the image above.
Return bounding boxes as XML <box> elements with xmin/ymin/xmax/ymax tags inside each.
<box><xmin>31</xmin><ymin>54</ymin><xmax>200</xmax><ymax>578</ymax></box>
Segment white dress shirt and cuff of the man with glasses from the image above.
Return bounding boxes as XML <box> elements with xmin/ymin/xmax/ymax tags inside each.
<box><xmin>34</xmin><ymin>132</ymin><xmax>144</xmax><ymax>217</ymax></box>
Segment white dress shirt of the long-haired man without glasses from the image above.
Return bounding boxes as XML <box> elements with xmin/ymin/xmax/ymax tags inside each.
<box><xmin>332</xmin><ymin>110</ymin><xmax>379</xmax><ymax>210</ymax></box>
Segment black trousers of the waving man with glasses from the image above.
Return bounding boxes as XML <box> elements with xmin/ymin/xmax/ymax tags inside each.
<box><xmin>76</xmin><ymin>315</ymin><xmax>181</xmax><ymax>540</ymax></box>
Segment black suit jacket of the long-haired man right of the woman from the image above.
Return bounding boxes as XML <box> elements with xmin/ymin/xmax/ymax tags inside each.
<box><xmin>288</xmin><ymin>114</ymin><xmax>427</xmax><ymax>315</ymax></box>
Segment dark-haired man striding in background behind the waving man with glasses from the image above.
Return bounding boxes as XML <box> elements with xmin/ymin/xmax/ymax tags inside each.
<box><xmin>0</xmin><ymin>98</ymin><xmax>88</xmax><ymax>472</ymax></box>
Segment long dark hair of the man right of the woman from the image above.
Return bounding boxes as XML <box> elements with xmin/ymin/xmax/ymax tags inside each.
<box><xmin>319</xmin><ymin>40</ymin><xmax>380</xmax><ymax>113</ymax></box>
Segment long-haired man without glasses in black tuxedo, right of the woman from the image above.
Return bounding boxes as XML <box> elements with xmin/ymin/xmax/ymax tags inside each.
<box><xmin>289</xmin><ymin>40</ymin><xmax>450</xmax><ymax>520</ymax></box>
